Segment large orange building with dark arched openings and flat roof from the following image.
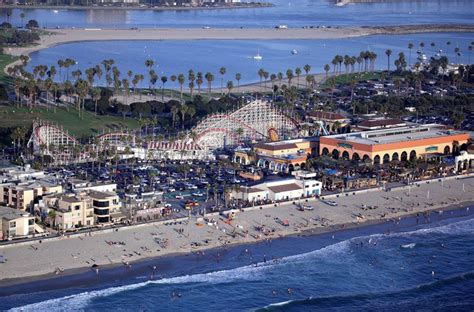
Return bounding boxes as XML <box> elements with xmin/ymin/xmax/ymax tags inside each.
<box><xmin>319</xmin><ymin>124</ymin><xmax>469</xmax><ymax>164</ymax></box>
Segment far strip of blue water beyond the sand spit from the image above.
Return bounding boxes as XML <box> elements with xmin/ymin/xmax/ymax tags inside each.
<box><xmin>0</xmin><ymin>0</ymin><xmax>474</xmax><ymax>28</ymax></box>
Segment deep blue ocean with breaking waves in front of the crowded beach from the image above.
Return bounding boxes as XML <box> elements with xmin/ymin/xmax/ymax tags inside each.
<box><xmin>0</xmin><ymin>207</ymin><xmax>474</xmax><ymax>311</ymax></box>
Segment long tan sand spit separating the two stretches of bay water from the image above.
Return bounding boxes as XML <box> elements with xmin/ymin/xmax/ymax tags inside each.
<box><xmin>5</xmin><ymin>25</ymin><xmax>474</xmax><ymax>55</ymax></box>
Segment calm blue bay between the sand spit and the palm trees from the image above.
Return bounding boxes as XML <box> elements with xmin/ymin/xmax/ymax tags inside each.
<box><xmin>28</xmin><ymin>33</ymin><xmax>474</xmax><ymax>91</ymax></box>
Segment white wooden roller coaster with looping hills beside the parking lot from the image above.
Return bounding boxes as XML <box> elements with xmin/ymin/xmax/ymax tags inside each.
<box><xmin>28</xmin><ymin>100</ymin><xmax>298</xmax><ymax>163</ymax></box>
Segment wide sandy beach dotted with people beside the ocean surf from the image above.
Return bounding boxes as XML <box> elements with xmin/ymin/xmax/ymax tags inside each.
<box><xmin>0</xmin><ymin>177</ymin><xmax>474</xmax><ymax>285</ymax></box>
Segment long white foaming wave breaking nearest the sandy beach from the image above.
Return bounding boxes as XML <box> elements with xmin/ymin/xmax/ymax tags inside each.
<box><xmin>10</xmin><ymin>219</ymin><xmax>474</xmax><ymax>311</ymax></box>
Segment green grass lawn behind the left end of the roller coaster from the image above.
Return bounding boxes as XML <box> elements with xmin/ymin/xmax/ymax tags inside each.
<box><xmin>0</xmin><ymin>106</ymin><xmax>139</xmax><ymax>138</ymax></box>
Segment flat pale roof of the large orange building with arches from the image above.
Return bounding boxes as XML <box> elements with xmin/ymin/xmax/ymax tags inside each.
<box><xmin>323</xmin><ymin>124</ymin><xmax>466</xmax><ymax>145</ymax></box>
